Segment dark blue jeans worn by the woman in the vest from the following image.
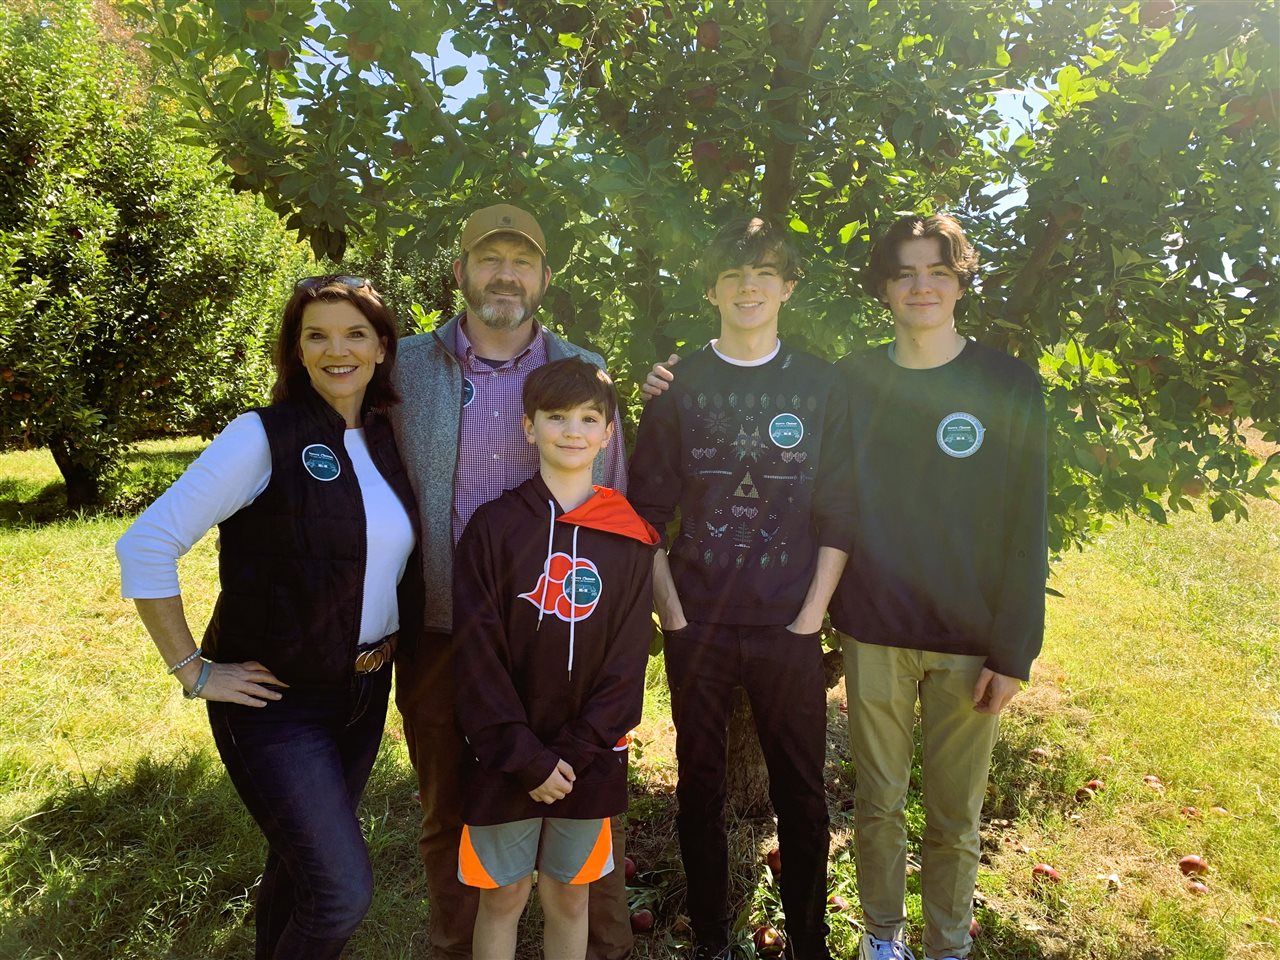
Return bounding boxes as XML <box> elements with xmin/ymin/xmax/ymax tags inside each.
<box><xmin>209</xmin><ymin>667</ymin><xmax>392</xmax><ymax>960</ymax></box>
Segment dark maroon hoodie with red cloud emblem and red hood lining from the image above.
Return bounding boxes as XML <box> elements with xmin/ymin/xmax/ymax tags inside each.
<box><xmin>453</xmin><ymin>475</ymin><xmax>660</xmax><ymax>826</ymax></box>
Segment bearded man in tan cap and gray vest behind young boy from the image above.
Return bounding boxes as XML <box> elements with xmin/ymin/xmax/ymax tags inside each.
<box><xmin>392</xmin><ymin>204</ymin><xmax>632</xmax><ymax>960</ymax></box>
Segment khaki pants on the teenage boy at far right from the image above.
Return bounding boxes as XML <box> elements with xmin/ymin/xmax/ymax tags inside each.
<box><xmin>841</xmin><ymin>634</ymin><xmax>997</xmax><ymax>957</ymax></box>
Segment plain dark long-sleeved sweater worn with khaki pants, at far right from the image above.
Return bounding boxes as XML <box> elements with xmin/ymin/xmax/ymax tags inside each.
<box><xmin>831</xmin><ymin>343</ymin><xmax>1047</xmax><ymax>680</ymax></box>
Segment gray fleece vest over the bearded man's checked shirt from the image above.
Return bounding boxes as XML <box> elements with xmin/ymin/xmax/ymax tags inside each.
<box><xmin>392</xmin><ymin>315</ymin><xmax>604</xmax><ymax>634</ymax></box>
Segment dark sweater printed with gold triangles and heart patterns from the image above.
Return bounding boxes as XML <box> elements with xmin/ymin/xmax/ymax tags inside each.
<box><xmin>627</xmin><ymin>343</ymin><xmax>852</xmax><ymax>626</ymax></box>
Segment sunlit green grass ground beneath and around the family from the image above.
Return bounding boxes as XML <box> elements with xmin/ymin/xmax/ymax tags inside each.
<box><xmin>0</xmin><ymin>442</ymin><xmax>1280</xmax><ymax>960</ymax></box>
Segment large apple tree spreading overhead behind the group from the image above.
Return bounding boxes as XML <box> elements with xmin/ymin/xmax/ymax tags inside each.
<box><xmin>129</xmin><ymin>0</ymin><xmax>1280</xmax><ymax>550</ymax></box>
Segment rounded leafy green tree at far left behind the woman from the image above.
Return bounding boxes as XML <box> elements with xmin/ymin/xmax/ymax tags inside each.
<box><xmin>0</xmin><ymin>3</ymin><xmax>303</xmax><ymax>508</ymax></box>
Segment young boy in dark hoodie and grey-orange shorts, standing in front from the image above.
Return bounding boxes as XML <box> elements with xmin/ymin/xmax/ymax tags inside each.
<box><xmin>453</xmin><ymin>357</ymin><xmax>659</xmax><ymax>960</ymax></box>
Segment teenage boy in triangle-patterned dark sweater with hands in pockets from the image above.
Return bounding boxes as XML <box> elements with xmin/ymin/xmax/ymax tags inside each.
<box><xmin>628</xmin><ymin>218</ymin><xmax>851</xmax><ymax>960</ymax></box>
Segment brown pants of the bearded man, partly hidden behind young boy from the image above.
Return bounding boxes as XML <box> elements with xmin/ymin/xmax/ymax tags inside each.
<box><xmin>396</xmin><ymin>634</ymin><xmax>634</xmax><ymax>960</ymax></box>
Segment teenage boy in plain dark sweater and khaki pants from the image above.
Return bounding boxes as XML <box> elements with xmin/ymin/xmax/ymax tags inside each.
<box><xmin>831</xmin><ymin>216</ymin><xmax>1047</xmax><ymax>960</ymax></box>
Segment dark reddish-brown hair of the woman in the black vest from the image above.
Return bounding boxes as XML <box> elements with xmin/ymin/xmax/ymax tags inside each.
<box><xmin>271</xmin><ymin>276</ymin><xmax>401</xmax><ymax>412</ymax></box>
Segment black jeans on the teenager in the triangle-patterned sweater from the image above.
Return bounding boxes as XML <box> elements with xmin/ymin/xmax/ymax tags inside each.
<box><xmin>664</xmin><ymin>622</ymin><xmax>828</xmax><ymax>960</ymax></box>
